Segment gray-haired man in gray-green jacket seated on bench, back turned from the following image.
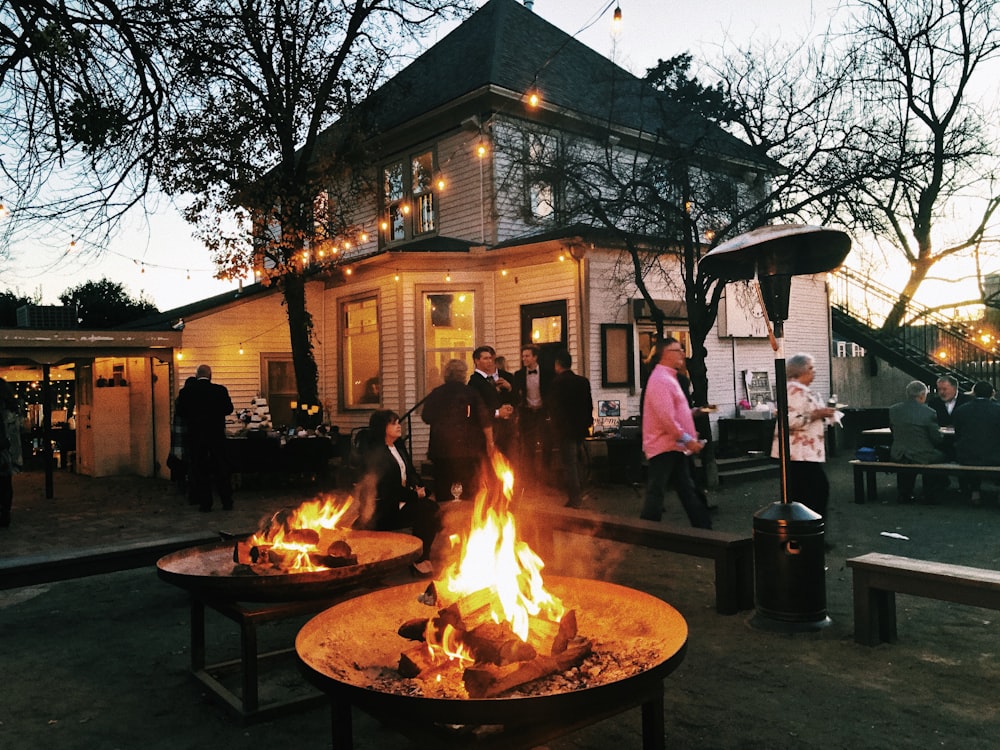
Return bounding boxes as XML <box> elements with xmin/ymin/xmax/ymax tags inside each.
<box><xmin>889</xmin><ymin>380</ymin><xmax>947</xmax><ymax>503</ymax></box>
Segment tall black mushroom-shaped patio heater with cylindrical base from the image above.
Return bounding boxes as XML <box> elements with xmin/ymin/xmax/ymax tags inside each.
<box><xmin>698</xmin><ymin>224</ymin><xmax>851</xmax><ymax>632</ymax></box>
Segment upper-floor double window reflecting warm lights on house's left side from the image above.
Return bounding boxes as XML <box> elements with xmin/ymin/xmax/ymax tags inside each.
<box><xmin>381</xmin><ymin>151</ymin><xmax>437</xmax><ymax>244</ymax></box>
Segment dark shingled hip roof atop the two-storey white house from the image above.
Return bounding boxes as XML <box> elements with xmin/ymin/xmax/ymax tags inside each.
<box><xmin>360</xmin><ymin>0</ymin><xmax>776</xmax><ymax>167</ymax></box>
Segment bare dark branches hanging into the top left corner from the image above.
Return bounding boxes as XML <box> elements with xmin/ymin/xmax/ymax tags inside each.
<box><xmin>0</xmin><ymin>0</ymin><xmax>165</xmax><ymax>254</ymax></box>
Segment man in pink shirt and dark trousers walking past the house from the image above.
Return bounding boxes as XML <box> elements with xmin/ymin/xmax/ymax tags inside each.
<box><xmin>639</xmin><ymin>336</ymin><xmax>712</xmax><ymax>529</ymax></box>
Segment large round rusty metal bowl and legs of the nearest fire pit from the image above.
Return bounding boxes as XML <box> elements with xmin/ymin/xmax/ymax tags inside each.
<box><xmin>295</xmin><ymin>577</ymin><xmax>687</xmax><ymax>748</ymax></box>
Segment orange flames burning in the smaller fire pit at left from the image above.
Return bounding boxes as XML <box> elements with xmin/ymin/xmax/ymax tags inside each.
<box><xmin>249</xmin><ymin>495</ymin><xmax>353</xmax><ymax>572</ymax></box>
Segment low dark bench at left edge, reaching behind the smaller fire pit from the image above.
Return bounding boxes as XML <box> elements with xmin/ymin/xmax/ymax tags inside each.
<box><xmin>0</xmin><ymin>532</ymin><xmax>219</xmax><ymax>590</ymax></box>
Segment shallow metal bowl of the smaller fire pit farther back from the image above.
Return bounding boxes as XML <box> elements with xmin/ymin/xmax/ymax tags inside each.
<box><xmin>156</xmin><ymin>531</ymin><xmax>423</xmax><ymax>602</ymax></box>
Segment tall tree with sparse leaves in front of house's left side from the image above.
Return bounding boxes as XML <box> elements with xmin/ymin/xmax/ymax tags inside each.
<box><xmin>153</xmin><ymin>0</ymin><xmax>468</xmax><ymax>418</ymax></box>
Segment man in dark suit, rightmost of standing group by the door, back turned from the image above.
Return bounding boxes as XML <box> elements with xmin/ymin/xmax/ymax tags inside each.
<box><xmin>545</xmin><ymin>349</ymin><xmax>594</xmax><ymax>508</ymax></box>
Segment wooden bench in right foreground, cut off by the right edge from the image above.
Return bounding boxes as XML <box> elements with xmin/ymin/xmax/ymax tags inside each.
<box><xmin>847</xmin><ymin>552</ymin><xmax>1000</xmax><ymax>646</ymax></box>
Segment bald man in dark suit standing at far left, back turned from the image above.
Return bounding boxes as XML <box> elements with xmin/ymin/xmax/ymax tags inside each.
<box><xmin>176</xmin><ymin>365</ymin><xmax>233</xmax><ymax>513</ymax></box>
